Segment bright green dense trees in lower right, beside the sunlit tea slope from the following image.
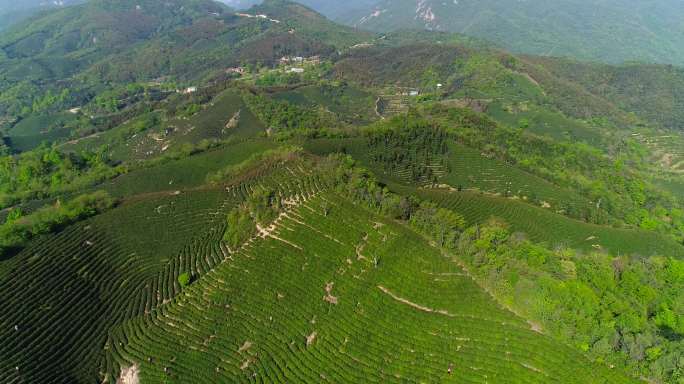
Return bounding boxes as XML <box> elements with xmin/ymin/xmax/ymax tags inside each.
<box><xmin>458</xmin><ymin>222</ymin><xmax>684</xmax><ymax>383</ymax></box>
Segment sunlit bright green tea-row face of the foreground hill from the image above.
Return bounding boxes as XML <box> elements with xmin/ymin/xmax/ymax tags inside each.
<box><xmin>106</xmin><ymin>193</ymin><xmax>635</xmax><ymax>384</ymax></box>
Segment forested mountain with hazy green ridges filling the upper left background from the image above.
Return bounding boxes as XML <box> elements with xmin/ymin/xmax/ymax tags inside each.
<box><xmin>0</xmin><ymin>0</ymin><xmax>368</xmax><ymax>122</ymax></box>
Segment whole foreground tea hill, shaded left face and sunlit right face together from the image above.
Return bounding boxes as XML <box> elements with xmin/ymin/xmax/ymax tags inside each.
<box><xmin>0</xmin><ymin>152</ymin><xmax>635</xmax><ymax>383</ymax></box>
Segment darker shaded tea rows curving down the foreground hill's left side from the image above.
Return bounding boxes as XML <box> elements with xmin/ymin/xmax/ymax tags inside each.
<box><xmin>0</xmin><ymin>159</ymin><xmax>322</xmax><ymax>383</ymax></box>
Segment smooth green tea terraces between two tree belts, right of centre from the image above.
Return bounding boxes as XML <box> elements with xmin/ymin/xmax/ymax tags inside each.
<box><xmin>305</xmin><ymin>139</ymin><xmax>684</xmax><ymax>257</ymax></box>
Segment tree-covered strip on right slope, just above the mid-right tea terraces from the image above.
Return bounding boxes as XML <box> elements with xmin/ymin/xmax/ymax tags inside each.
<box><xmin>429</xmin><ymin>106</ymin><xmax>681</xmax><ymax>238</ymax></box>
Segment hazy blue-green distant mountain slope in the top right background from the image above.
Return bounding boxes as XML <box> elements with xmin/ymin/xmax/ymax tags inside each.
<box><xmin>338</xmin><ymin>0</ymin><xmax>684</xmax><ymax>64</ymax></box>
